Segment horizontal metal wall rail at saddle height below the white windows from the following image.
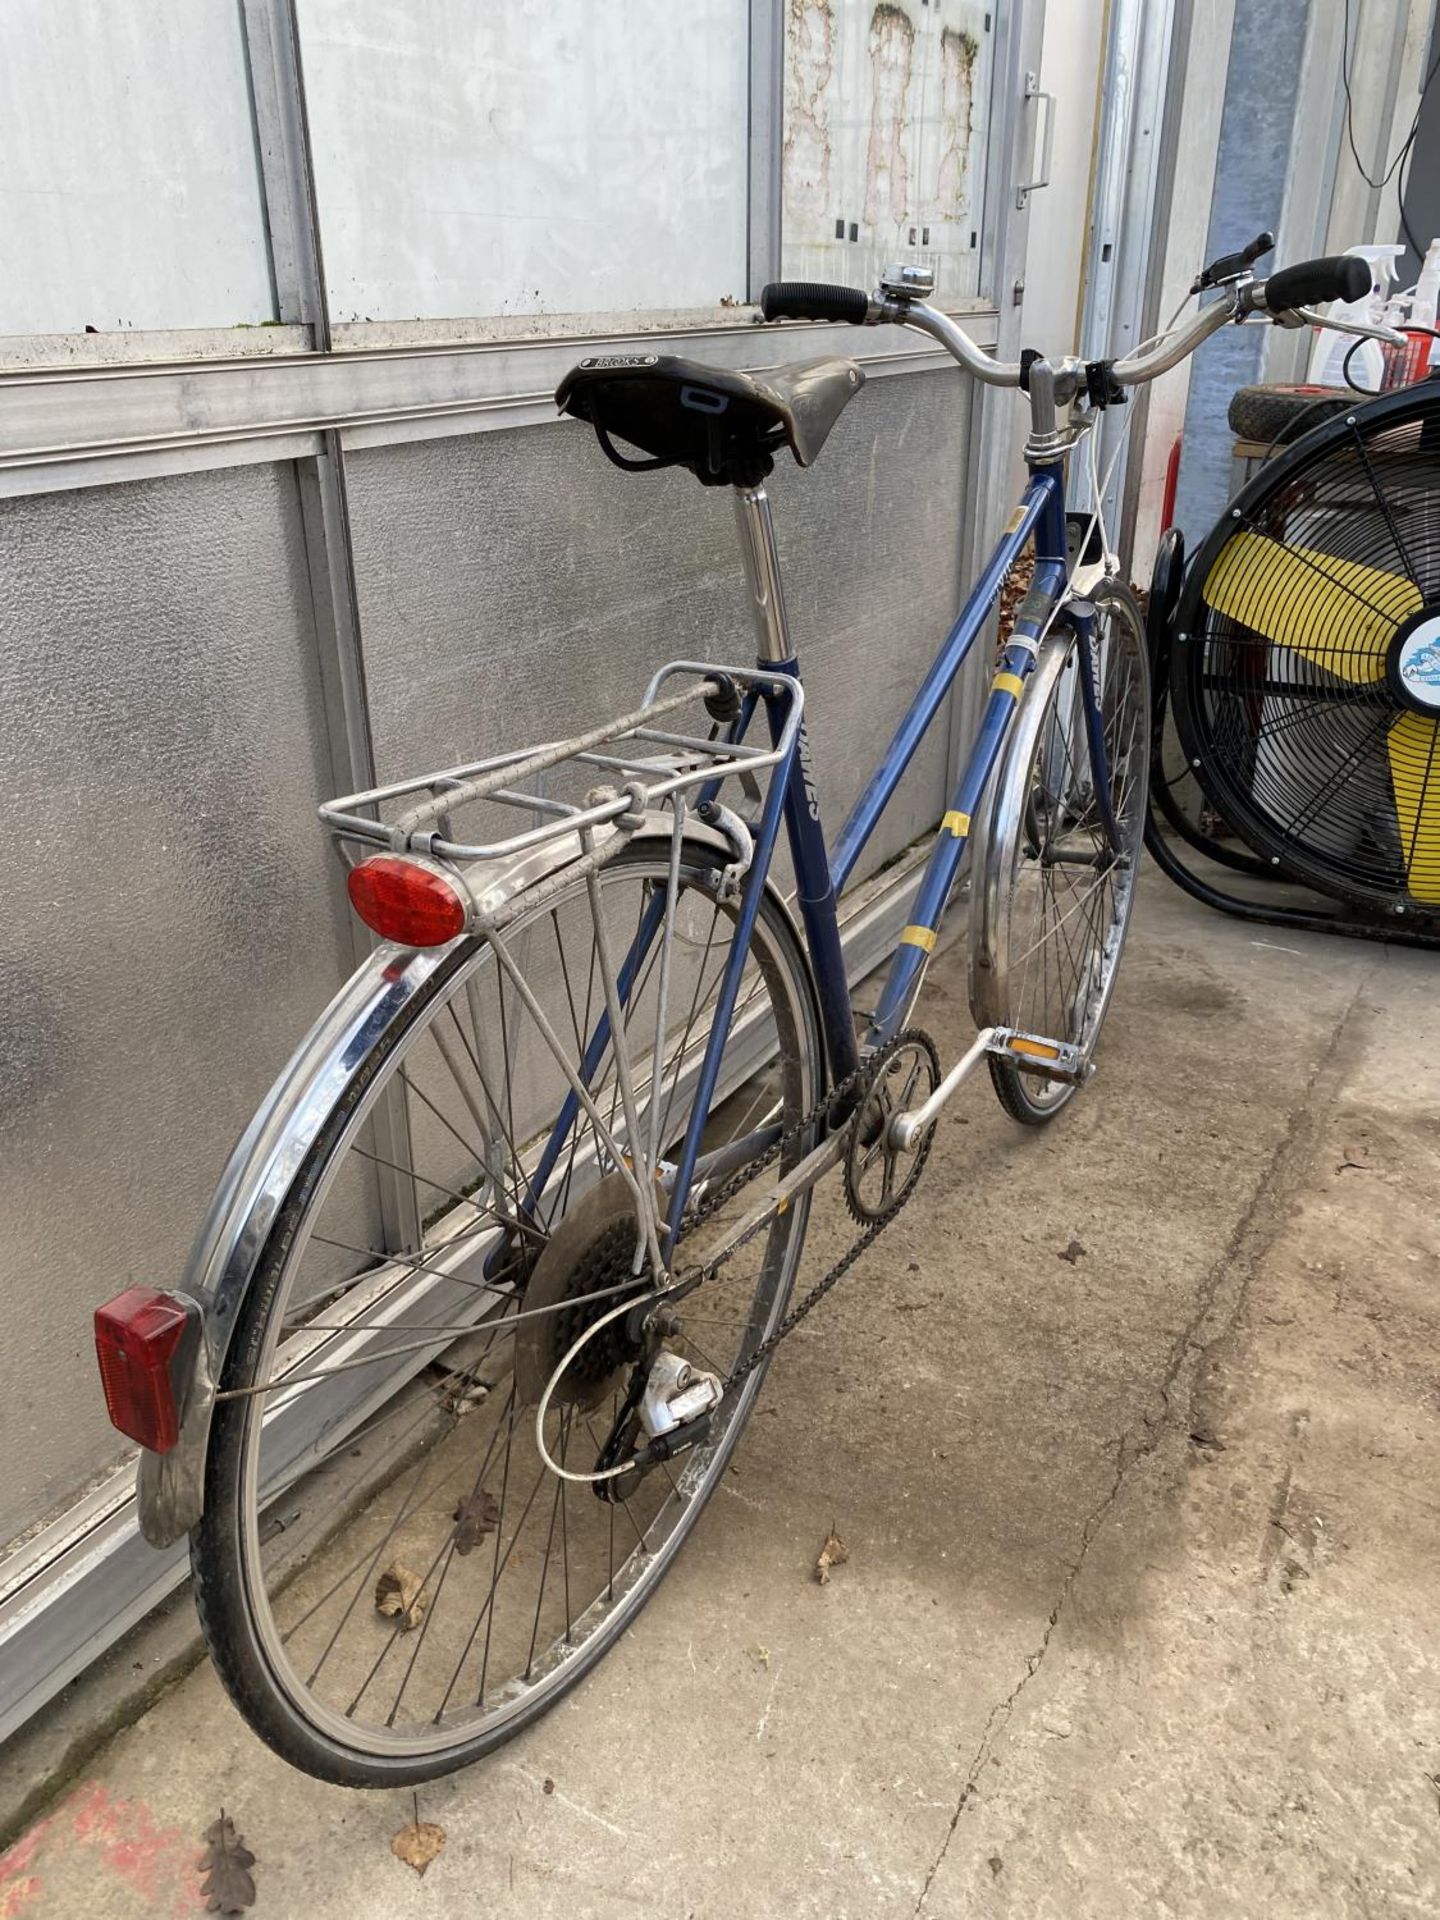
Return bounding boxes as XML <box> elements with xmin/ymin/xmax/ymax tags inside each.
<box><xmin>0</xmin><ymin>307</ymin><xmax>996</xmax><ymax>495</ymax></box>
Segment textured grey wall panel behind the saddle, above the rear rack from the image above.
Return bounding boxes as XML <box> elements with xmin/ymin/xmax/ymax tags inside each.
<box><xmin>349</xmin><ymin>372</ymin><xmax>970</xmax><ymax>844</ymax></box>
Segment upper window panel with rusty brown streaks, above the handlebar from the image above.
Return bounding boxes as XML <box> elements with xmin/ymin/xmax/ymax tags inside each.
<box><xmin>781</xmin><ymin>0</ymin><xmax>995</xmax><ymax>300</ymax></box>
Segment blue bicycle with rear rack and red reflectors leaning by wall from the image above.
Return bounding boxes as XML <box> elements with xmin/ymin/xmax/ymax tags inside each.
<box><xmin>96</xmin><ymin>243</ymin><xmax>1350</xmax><ymax>1786</ymax></box>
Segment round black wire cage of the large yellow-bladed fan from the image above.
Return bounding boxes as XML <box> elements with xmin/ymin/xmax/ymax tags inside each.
<box><xmin>1171</xmin><ymin>380</ymin><xmax>1440</xmax><ymax>916</ymax></box>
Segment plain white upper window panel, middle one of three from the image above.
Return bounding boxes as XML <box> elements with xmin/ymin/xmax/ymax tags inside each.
<box><xmin>300</xmin><ymin>0</ymin><xmax>749</xmax><ymax>321</ymax></box>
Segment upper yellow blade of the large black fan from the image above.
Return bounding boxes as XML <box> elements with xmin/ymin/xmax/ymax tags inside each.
<box><xmin>1206</xmin><ymin>534</ymin><xmax>1421</xmax><ymax>685</ymax></box>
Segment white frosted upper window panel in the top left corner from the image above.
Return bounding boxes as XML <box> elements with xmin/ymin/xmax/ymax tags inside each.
<box><xmin>0</xmin><ymin>0</ymin><xmax>275</xmax><ymax>334</ymax></box>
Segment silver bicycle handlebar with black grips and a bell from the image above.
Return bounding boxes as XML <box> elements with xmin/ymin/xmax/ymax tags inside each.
<box><xmin>760</xmin><ymin>251</ymin><xmax>1390</xmax><ymax>399</ymax></box>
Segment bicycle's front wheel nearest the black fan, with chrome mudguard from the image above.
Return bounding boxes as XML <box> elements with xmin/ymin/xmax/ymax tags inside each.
<box><xmin>970</xmin><ymin>582</ymin><xmax>1150</xmax><ymax>1127</ymax></box>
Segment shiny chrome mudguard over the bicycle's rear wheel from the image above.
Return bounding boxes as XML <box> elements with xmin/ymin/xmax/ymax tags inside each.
<box><xmin>136</xmin><ymin>812</ymin><xmax>732</xmax><ymax>1548</ymax></box>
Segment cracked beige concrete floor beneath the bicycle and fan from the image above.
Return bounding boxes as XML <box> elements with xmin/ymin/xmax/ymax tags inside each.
<box><xmin>0</xmin><ymin>876</ymin><xmax>1440</xmax><ymax>1920</ymax></box>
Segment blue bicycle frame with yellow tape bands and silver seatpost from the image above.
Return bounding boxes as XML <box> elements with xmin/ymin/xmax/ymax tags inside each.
<box><xmin>528</xmin><ymin>451</ymin><xmax>1112</xmax><ymax>1240</ymax></box>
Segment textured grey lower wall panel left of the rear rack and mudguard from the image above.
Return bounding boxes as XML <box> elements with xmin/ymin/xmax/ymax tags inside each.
<box><xmin>0</xmin><ymin>465</ymin><xmax>360</xmax><ymax>1540</ymax></box>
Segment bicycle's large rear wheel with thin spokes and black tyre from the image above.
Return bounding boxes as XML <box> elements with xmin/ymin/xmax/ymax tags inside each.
<box><xmin>192</xmin><ymin>845</ymin><xmax>824</xmax><ymax>1786</ymax></box>
